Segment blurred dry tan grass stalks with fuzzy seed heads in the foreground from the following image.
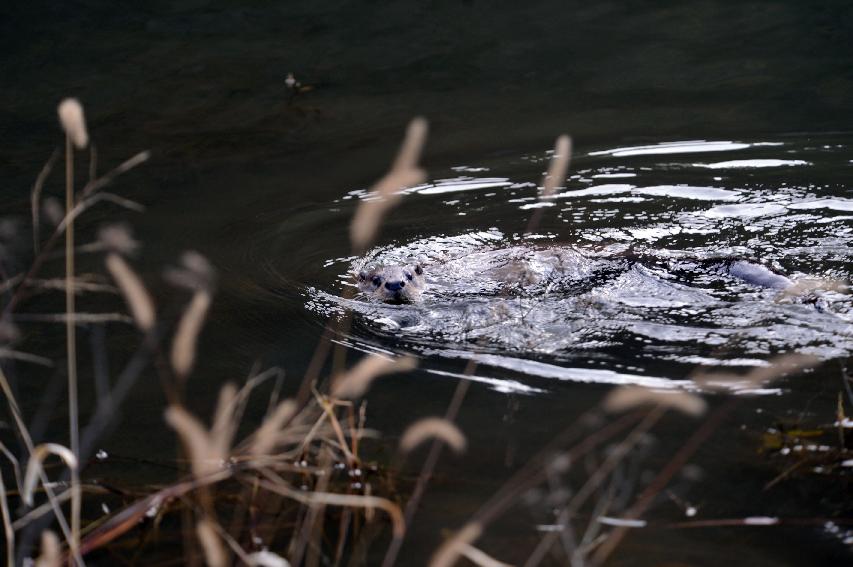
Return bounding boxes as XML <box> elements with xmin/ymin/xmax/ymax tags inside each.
<box><xmin>0</xmin><ymin>101</ymin><xmax>843</xmax><ymax>567</ymax></box>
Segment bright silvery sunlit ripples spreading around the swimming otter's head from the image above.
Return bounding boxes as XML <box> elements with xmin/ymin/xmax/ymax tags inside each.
<box><xmin>296</xmin><ymin>141</ymin><xmax>853</xmax><ymax>392</ymax></box>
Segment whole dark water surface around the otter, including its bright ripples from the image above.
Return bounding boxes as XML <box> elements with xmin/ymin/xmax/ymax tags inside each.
<box><xmin>0</xmin><ymin>1</ymin><xmax>853</xmax><ymax>565</ymax></box>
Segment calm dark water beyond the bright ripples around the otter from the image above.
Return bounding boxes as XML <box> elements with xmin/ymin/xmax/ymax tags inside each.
<box><xmin>0</xmin><ymin>1</ymin><xmax>853</xmax><ymax>565</ymax></box>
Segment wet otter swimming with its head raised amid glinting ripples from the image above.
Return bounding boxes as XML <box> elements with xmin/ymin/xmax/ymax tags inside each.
<box><xmin>324</xmin><ymin>235</ymin><xmax>853</xmax><ymax>360</ymax></box>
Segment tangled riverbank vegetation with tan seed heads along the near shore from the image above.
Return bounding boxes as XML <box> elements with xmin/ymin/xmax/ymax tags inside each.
<box><xmin>0</xmin><ymin>100</ymin><xmax>853</xmax><ymax>567</ymax></box>
